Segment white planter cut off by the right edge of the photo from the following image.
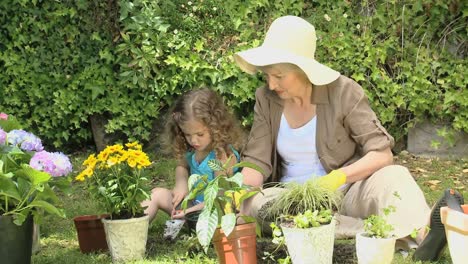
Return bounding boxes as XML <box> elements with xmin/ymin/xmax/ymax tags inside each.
<box><xmin>440</xmin><ymin>204</ymin><xmax>468</xmax><ymax>264</ymax></box>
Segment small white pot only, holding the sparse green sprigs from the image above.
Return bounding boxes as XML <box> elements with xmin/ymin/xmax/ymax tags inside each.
<box><xmin>356</xmin><ymin>232</ymin><xmax>396</xmax><ymax>264</ymax></box>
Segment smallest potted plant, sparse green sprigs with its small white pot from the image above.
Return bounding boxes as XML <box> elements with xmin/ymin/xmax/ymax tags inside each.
<box><xmin>356</xmin><ymin>205</ymin><xmax>396</xmax><ymax>264</ymax></box>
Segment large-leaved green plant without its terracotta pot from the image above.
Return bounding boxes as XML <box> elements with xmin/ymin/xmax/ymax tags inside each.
<box><xmin>182</xmin><ymin>159</ymin><xmax>262</xmax><ymax>252</ymax></box>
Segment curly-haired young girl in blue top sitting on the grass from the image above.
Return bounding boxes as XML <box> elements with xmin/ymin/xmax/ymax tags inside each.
<box><xmin>142</xmin><ymin>88</ymin><xmax>242</xmax><ymax>221</ymax></box>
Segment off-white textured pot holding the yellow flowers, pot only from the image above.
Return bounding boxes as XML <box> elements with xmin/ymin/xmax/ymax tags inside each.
<box><xmin>102</xmin><ymin>215</ymin><xmax>149</xmax><ymax>262</ymax></box>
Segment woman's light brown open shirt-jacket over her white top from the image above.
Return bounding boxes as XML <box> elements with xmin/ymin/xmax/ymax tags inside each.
<box><xmin>242</xmin><ymin>75</ymin><xmax>394</xmax><ymax>182</ymax></box>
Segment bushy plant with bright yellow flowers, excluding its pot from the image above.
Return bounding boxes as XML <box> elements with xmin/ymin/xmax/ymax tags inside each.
<box><xmin>75</xmin><ymin>142</ymin><xmax>151</xmax><ymax>219</ymax></box>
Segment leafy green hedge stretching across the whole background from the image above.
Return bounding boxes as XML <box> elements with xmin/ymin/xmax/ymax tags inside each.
<box><xmin>0</xmin><ymin>0</ymin><xmax>468</xmax><ymax>149</ymax></box>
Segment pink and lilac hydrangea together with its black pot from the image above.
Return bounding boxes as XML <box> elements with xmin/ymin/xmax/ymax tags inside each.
<box><xmin>0</xmin><ymin>113</ymin><xmax>72</xmax><ymax>263</ymax></box>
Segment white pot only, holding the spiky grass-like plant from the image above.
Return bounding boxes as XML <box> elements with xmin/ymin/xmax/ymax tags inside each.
<box><xmin>281</xmin><ymin>219</ymin><xmax>336</xmax><ymax>264</ymax></box>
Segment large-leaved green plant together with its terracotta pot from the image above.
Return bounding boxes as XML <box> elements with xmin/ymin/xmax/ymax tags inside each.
<box><xmin>182</xmin><ymin>160</ymin><xmax>261</xmax><ymax>263</ymax></box>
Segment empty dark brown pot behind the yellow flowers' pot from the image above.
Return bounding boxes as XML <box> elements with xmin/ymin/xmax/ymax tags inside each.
<box><xmin>73</xmin><ymin>215</ymin><xmax>108</xmax><ymax>253</ymax></box>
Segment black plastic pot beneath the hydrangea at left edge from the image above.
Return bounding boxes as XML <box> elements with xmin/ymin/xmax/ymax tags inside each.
<box><xmin>0</xmin><ymin>215</ymin><xmax>33</xmax><ymax>264</ymax></box>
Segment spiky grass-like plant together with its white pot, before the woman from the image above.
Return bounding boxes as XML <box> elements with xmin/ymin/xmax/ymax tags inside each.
<box><xmin>267</xmin><ymin>180</ymin><xmax>342</xmax><ymax>263</ymax></box>
